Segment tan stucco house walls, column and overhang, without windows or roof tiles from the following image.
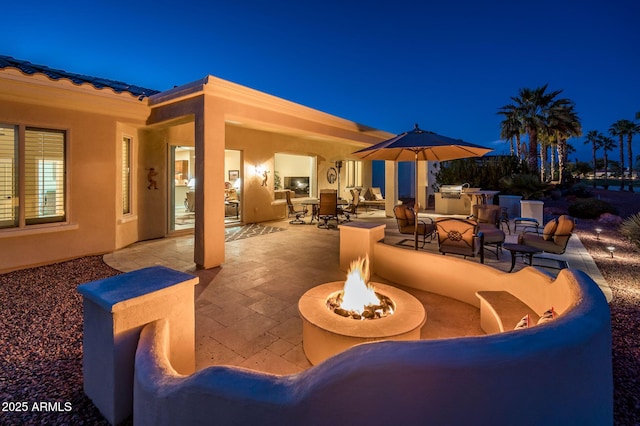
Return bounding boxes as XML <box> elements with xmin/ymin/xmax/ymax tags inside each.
<box><xmin>0</xmin><ymin>67</ymin><xmax>391</xmax><ymax>272</ymax></box>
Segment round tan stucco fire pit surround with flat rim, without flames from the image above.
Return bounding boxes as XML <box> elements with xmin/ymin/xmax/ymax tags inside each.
<box><xmin>298</xmin><ymin>281</ymin><xmax>426</xmax><ymax>365</ymax></box>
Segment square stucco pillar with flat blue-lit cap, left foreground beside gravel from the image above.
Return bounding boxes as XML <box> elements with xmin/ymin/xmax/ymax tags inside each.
<box><xmin>78</xmin><ymin>266</ymin><xmax>198</xmax><ymax>424</ymax></box>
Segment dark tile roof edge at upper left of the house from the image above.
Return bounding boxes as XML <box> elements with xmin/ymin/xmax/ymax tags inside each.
<box><xmin>0</xmin><ymin>55</ymin><xmax>160</xmax><ymax>99</ymax></box>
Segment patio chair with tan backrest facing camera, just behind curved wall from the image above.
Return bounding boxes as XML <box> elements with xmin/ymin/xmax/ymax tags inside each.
<box><xmin>436</xmin><ymin>217</ymin><xmax>484</xmax><ymax>263</ymax></box>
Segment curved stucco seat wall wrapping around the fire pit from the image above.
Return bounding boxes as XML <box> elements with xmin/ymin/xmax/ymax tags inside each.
<box><xmin>134</xmin><ymin>246</ymin><xmax>613</xmax><ymax>425</ymax></box>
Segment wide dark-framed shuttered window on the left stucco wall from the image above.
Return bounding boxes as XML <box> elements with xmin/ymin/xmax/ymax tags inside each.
<box><xmin>0</xmin><ymin>125</ymin><xmax>66</xmax><ymax>228</ymax></box>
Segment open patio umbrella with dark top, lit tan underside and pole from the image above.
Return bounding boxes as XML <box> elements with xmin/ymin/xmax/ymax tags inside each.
<box><xmin>353</xmin><ymin>124</ymin><xmax>492</xmax><ymax>250</ymax></box>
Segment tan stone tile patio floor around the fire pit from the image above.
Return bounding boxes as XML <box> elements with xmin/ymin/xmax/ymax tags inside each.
<box><xmin>104</xmin><ymin>211</ymin><xmax>608</xmax><ymax>374</ymax></box>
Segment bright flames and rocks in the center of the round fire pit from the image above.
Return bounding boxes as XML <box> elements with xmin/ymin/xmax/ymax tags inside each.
<box><xmin>327</xmin><ymin>256</ymin><xmax>394</xmax><ymax>319</ymax></box>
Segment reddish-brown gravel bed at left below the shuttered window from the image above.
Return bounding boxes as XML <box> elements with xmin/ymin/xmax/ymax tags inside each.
<box><xmin>0</xmin><ymin>256</ymin><xmax>118</xmax><ymax>425</ymax></box>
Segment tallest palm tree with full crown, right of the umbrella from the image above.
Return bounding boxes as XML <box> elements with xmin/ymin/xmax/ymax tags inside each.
<box><xmin>500</xmin><ymin>84</ymin><xmax>572</xmax><ymax>173</ymax></box>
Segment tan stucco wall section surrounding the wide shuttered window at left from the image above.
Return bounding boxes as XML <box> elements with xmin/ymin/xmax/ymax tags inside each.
<box><xmin>0</xmin><ymin>83</ymin><xmax>145</xmax><ymax>271</ymax></box>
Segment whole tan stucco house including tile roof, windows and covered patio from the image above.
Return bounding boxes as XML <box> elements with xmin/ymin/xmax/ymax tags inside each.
<box><xmin>0</xmin><ymin>56</ymin><xmax>394</xmax><ymax>272</ymax></box>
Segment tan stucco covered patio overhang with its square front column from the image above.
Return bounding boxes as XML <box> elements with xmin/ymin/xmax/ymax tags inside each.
<box><xmin>147</xmin><ymin>76</ymin><xmax>392</xmax><ymax>268</ymax></box>
